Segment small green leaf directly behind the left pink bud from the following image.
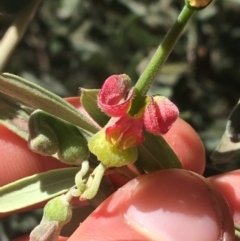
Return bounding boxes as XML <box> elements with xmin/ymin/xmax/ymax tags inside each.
<box><xmin>81</xmin><ymin>89</ymin><xmax>110</xmax><ymax>127</ymax></box>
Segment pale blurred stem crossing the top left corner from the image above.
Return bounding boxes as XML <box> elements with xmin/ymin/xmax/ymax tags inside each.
<box><xmin>0</xmin><ymin>0</ymin><xmax>42</xmax><ymax>72</ymax></box>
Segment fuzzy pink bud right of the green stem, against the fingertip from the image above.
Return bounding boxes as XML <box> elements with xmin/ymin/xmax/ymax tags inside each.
<box><xmin>143</xmin><ymin>96</ymin><xmax>179</xmax><ymax>135</ymax></box>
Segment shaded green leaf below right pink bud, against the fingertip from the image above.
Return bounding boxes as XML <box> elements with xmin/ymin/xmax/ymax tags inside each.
<box><xmin>137</xmin><ymin>132</ymin><xmax>182</xmax><ymax>173</ymax></box>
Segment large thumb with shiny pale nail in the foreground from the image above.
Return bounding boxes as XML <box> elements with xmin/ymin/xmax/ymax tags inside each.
<box><xmin>68</xmin><ymin>169</ymin><xmax>234</xmax><ymax>241</ymax></box>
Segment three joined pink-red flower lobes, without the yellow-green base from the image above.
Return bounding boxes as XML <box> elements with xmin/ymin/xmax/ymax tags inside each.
<box><xmin>95</xmin><ymin>74</ymin><xmax>178</xmax><ymax>150</ymax></box>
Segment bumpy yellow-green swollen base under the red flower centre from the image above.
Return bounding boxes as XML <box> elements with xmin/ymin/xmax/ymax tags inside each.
<box><xmin>88</xmin><ymin>129</ymin><xmax>138</xmax><ymax>167</ymax></box>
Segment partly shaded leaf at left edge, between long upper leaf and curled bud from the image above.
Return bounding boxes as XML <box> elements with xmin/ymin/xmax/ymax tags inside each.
<box><xmin>0</xmin><ymin>93</ymin><xmax>33</xmax><ymax>140</ymax></box>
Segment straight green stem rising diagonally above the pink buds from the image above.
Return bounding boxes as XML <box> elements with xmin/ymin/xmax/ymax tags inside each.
<box><xmin>135</xmin><ymin>6</ymin><xmax>194</xmax><ymax>96</ymax></box>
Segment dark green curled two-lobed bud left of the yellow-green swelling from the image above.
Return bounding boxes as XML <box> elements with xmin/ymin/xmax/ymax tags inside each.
<box><xmin>28</xmin><ymin>110</ymin><xmax>89</xmax><ymax>165</ymax></box>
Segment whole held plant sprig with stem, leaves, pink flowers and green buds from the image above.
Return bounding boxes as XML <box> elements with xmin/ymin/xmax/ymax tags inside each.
<box><xmin>3</xmin><ymin>0</ymin><xmax>236</xmax><ymax>241</ymax></box>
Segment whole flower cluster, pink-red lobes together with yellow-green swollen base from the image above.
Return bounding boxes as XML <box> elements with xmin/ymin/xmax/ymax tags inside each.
<box><xmin>89</xmin><ymin>74</ymin><xmax>178</xmax><ymax>166</ymax></box>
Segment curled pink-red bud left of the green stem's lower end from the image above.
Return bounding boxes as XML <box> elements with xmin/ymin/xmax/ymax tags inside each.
<box><xmin>98</xmin><ymin>74</ymin><xmax>133</xmax><ymax>117</ymax></box>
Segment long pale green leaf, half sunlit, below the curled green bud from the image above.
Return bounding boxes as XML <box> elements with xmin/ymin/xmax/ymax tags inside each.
<box><xmin>0</xmin><ymin>167</ymin><xmax>79</xmax><ymax>213</ymax></box>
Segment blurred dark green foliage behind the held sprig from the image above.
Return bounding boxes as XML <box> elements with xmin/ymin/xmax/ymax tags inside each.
<box><xmin>0</xmin><ymin>0</ymin><xmax>240</xmax><ymax>241</ymax></box>
